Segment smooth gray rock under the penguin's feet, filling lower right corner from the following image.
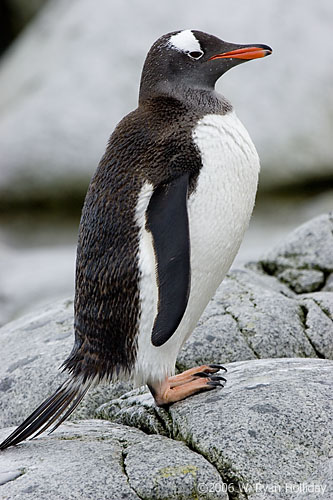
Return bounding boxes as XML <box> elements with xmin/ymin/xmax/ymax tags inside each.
<box><xmin>94</xmin><ymin>359</ymin><xmax>333</xmax><ymax>500</ymax></box>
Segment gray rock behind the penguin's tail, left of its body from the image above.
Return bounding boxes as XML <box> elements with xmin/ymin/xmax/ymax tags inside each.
<box><xmin>0</xmin><ymin>299</ymin><xmax>131</xmax><ymax>427</ymax></box>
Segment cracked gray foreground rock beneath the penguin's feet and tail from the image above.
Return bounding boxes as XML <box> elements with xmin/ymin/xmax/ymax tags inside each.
<box><xmin>0</xmin><ymin>359</ymin><xmax>333</xmax><ymax>500</ymax></box>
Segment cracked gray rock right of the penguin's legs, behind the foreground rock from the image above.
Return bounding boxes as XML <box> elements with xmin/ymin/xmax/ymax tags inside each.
<box><xmin>177</xmin><ymin>260</ymin><xmax>333</xmax><ymax>370</ymax></box>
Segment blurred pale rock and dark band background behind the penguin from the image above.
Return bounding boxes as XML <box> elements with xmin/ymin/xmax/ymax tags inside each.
<box><xmin>0</xmin><ymin>0</ymin><xmax>333</xmax><ymax>323</ymax></box>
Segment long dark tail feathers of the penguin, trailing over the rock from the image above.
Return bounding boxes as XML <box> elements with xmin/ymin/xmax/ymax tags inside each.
<box><xmin>0</xmin><ymin>378</ymin><xmax>94</xmax><ymax>450</ymax></box>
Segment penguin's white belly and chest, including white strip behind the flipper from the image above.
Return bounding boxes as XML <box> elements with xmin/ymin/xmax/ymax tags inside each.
<box><xmin>133</xmin><ymin>112</ymin><xmax>260</xmax><ymax>385</ymax></box>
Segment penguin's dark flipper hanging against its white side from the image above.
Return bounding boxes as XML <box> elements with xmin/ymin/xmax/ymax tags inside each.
<box><xmin>146</xmin><ymin>173</ymin><xmax>191</xmax><ymax>347</ymax></box>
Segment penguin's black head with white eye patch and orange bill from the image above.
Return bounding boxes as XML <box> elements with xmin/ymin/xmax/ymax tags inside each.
<box><xmin>140</xmin><ymin>30</ymin><xmax>272</xmax><ymax>101</ymax></box>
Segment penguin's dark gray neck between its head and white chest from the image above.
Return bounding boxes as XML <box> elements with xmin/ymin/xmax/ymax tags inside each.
<box><xmin>139</xmin><ymin>80</ymin><xmax>233</xmax><ymax>116</ymax></box>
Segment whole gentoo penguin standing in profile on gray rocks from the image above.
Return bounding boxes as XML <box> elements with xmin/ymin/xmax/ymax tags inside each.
<box><xmin>0</xmin><ymin>30</ymin><xmax>272</xmax><ymax>449</ymax></box>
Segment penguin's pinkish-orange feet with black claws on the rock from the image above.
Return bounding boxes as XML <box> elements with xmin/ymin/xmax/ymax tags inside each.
<box><xmin>148</xmin><ymin>365</ymin><xmax>226</xmax><ymax>406</ymax></box>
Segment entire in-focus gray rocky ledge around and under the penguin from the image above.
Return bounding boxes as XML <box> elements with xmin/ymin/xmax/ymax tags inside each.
<box><xmin>0</xmin><ymin>214</ymin><xmax>333</xmax><ymax>500</ymax></box>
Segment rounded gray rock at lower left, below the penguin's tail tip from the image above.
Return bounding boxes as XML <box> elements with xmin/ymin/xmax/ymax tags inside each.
<box><xmin>0</xmin><ymin>420</ymin><xmax>228</xmax><ymax>500</ymax></box>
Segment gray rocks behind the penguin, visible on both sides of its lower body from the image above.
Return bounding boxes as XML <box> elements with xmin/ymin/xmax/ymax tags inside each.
<box><xmin>0</xmin><ymin>214</ymin><xmax>333</xmax><ymax>427</ymax></box>
